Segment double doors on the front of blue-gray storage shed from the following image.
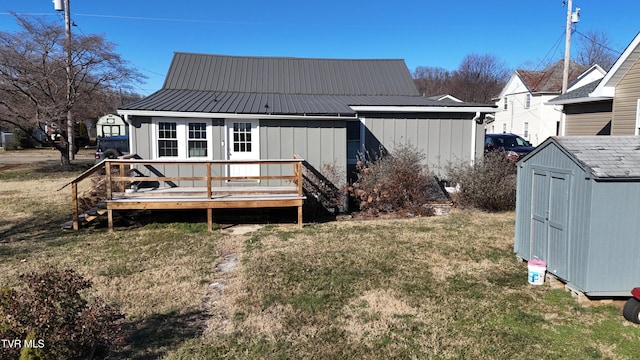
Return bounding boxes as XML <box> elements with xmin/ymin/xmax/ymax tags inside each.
<box><xmin>531</xmin><ymin>170</ymin><xmax>570</xmax><ymax>278</ymax></box>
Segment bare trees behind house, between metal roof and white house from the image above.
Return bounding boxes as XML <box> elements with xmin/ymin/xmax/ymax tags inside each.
<box><xmin>451</xmin><ymin>54</ymin><xmax>511</xmax><ymax>104</ymax></box>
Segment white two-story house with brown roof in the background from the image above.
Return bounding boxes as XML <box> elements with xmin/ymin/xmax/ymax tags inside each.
<box><xmin>485</xmin><ymin>61</ymin><xmax>605</xmax><ymax>146</ymax></box>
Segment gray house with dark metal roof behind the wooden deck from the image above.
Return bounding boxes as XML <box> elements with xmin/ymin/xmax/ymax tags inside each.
<box><xmin>118</xmin><ymin>53</ymin><xmax>495</xmax><ymax>180</ymax></box>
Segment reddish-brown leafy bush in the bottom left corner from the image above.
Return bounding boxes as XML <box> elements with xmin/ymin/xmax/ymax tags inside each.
<box><xmin>0</xmin><ymin>268</ymin><xmax>122</xmax><ymax>359</ymax></box>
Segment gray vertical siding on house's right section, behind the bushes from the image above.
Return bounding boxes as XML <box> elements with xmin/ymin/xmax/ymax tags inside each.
<box><xmin>364</xmin><ymin>114</ymin><xmax>484</xmax><ymax>175</ymax></box>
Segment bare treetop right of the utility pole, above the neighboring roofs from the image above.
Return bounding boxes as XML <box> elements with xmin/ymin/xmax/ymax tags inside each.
<box><xmin>576</xmin><ymin>31</ymin><xmax>619</xmax><ymax>71</ymax></box>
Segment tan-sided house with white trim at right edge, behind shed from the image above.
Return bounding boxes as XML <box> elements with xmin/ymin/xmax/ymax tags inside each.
<box><xmin>548</xmin><ymin>33</ymin><xmax>640</xmax><ymax>136</ymax></box>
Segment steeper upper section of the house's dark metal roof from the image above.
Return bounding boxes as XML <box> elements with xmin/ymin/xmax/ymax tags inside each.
<box><xmin>163</xmin><ymin>53</ymin><xmax>420</xmax><ymax>96</ymax></box>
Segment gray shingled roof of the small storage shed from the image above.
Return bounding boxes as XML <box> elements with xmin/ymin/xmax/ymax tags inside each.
<box><xmin>551</xmin><ymin>136</ymin><xmax>640</xmax><ymax>179</ymax></box>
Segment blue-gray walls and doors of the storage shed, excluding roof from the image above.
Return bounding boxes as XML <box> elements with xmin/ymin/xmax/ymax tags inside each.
<box><xmin>514</xmin><ymin>141</ymin><xmax>640</xmax><ymax>296</ymax></box>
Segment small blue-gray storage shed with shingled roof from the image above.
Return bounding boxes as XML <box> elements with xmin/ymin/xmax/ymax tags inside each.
<box><xmin>514</xmin><ymin>136</ymin><xmax>640</xmax><ymax>297</ymax></box>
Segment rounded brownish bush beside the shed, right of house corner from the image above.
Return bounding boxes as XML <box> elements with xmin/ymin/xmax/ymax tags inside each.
<box><xmin>446</xmin><ymin>152</ymin><xmax>516</xmax><ymax>211</ymax></box>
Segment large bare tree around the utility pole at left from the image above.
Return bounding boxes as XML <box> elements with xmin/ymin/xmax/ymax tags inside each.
<box><xmin>0</xmin><ymin>14</ymin><xmax>144</xmax><ymax>165</ymax></box>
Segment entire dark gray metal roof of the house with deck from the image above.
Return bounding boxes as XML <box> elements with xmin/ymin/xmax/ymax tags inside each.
<box><xmin>120</xmin><ymin>53</ymin><xmax>493</xmax><ymax>115</ymax></box>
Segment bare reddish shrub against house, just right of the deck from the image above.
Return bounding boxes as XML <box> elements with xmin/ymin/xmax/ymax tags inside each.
<box><xmin>349</xmin><ymin>144</ymin><xmax>433</xmax><ymax>216</ymax></box>
